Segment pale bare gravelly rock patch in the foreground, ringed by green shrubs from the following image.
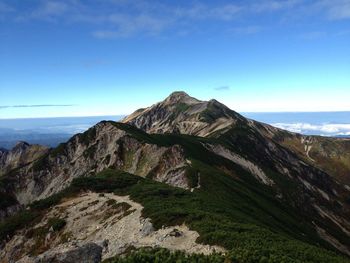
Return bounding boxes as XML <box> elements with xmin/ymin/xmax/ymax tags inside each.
<box><xmin>0</xmin><ymin>193</ymin><xmax>225</xmax><ymax>263</ymax></box>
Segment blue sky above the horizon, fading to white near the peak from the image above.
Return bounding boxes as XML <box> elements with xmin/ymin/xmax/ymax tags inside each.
<box><xmin>0</xmin><ymin>0</ymin><xmax>350</xmax><ymax>118</ymax></box>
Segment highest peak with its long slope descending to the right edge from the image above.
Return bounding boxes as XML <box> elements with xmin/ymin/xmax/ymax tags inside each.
<box><xmin>122</xmin><ymin>92</ymin><xmax>350</xmax><ymax>185</ymax></box>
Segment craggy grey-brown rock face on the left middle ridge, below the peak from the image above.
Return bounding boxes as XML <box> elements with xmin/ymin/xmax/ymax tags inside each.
<box><xmin>1</xmin><ymin>122</ymin><xmax>189</xmax><ymax>204</ymax></box>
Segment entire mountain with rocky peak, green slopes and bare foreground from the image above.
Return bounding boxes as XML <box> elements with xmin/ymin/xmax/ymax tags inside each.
<box><xmin>0</xmin><ymin>92</ymin><xmax>350</xmax><ymax>263</ymax></box>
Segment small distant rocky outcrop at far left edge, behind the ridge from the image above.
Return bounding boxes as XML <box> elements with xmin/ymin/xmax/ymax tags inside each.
<box><xmin>0</xmin><ymin>142</ymin><xmax>48</xmax><ymax>176</ymax></box>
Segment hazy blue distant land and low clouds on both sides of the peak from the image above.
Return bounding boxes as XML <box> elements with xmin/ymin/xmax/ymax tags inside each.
<box><xmin>0</xmin><ymin>111</ymin><xmax>350</xmax><ymax>149</ymax></box>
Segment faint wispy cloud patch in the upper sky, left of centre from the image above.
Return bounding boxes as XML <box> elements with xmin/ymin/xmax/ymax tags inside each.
<box><xmin>93</xmin><ymin>4</ymin><xmax>241</xmax><ymax>38</ymax></box>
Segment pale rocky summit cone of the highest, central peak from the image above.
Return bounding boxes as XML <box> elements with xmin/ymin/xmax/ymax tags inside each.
<box><xmin>122</xmin><ymin>92</ymin><xmax>243</xmax><ymax>136</ymax></box>
